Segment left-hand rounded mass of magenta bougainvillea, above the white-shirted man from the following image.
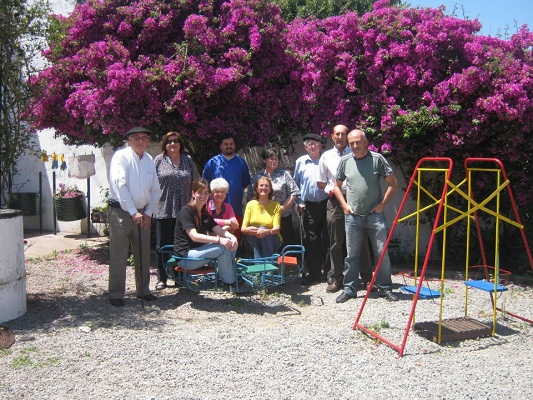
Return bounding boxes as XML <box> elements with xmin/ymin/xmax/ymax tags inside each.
<box><xmin>26</xmin><ymin>0</ymin><xmax>291</xmax><ymax>161</ymax></box>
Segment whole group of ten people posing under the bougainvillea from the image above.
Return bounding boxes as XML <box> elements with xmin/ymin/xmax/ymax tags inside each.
<box><xmin>105</xmin><ymin>125</ymin><xmax>398</xmax><ymax>306</ymax></box>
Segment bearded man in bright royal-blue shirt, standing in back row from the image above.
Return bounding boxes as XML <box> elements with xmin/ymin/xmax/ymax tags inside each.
<box><xmin>202</xmin><ymin>136</ymin><xmax>250</xmax><ymax>238</ymax></box>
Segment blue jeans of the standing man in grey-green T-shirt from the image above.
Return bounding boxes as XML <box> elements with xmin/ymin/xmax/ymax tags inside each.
<box><xmin>344</xmin><ymin>212</ymin><xmax>392</xmax><ymax>295</ymax></box>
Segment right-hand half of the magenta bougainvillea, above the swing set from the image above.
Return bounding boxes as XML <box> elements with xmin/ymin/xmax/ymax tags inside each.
<box><xmin>288</xmin><ymin>0</ymin><xmax>533</xmax><ymax>204</ymax></box>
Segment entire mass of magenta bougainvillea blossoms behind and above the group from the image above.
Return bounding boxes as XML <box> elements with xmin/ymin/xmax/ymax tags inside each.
<box><xmin>27</xmin><ymin>0</ymin><xmax>533</xmax><ymax>208</ymax></box>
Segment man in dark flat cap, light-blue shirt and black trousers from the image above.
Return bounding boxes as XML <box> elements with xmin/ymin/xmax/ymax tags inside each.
<box><xmin>294</xmin><ymin>134</ymin><xmax>330</xmax><ymax>286</ymax></box>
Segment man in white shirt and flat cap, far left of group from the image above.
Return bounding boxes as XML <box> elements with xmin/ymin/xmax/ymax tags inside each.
<box><xmin>108</xmin><ymin>126</ymin><xmax>161</xmax><ymax>307</ymax></box>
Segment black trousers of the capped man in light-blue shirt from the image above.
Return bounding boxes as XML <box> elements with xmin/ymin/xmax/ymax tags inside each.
<box><xmin>303</xmin><ymin>200</ymin><xmax>330</xmax><ymax>280</ymax></box>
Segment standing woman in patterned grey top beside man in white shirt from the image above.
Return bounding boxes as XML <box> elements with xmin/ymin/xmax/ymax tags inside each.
<box><xmin>153</xmin><ymin>132</ymin><xmax>199</xmax><ymax>290</ymax></box>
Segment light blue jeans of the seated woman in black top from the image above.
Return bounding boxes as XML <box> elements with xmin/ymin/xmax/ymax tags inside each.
<box><xmin>178</xmin><ymin>243</ymin><xmax>236</xmax><ymax>283</ymax></box>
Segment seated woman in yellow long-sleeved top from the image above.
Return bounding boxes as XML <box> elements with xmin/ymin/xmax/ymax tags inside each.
<box><xmin>241</xmin><ymin>176</ymin><xmax>281</xmax><ymax>258</ymax></box>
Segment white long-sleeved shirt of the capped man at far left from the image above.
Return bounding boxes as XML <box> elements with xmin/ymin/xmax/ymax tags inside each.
<box><xmin>109</xmin><ymin>147</ymin><xmax>161</xmax><ymax>216</ymax></box>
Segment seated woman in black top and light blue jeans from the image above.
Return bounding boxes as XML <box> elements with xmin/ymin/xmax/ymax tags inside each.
<box><xmin>174</xmin><ymin>179</ymin><xmax>238</xmax><ymax>284</ymax></box>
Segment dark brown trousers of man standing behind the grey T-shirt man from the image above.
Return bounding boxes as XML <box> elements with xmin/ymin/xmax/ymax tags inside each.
<box><xmin>327</xmin><ymin>197</ymin><xmax>373</xmax><ymax>283</ymax></box>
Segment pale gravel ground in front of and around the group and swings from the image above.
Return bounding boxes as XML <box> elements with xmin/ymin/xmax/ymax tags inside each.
<box><xmin>0</xmin><ymin>244</ymin><xmax>533</xmax><ymax>399</ymax></box>
